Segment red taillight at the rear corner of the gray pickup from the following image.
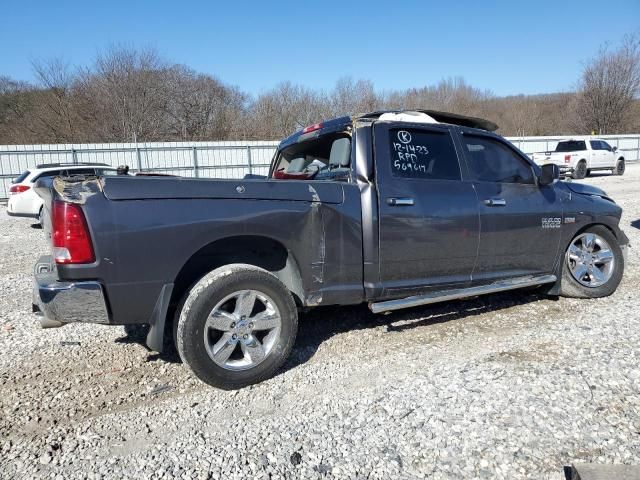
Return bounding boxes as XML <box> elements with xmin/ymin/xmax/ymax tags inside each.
<box><xmin>51</xmin><ymin>200</ymin><xmax>95</xmax><ymax>264</ymax></box>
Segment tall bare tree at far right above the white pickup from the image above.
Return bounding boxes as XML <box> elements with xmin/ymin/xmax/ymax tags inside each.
<box><xmin>576</xmin><ymin>36</ymin><xmax>640</xmax><ymax>134</ymax></box>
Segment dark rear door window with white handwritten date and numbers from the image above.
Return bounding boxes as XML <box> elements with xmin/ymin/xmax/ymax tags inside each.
<box><xmin>389</xmin><ymin>128</ymin><xmax>461</xmax><ymax>180</ymax></box>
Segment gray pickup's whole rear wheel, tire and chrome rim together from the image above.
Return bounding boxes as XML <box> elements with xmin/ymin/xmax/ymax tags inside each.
<box><xmin>176</xmin><ymin>264</ymin><xmax>298</xmax><ymax>389</ymax></box>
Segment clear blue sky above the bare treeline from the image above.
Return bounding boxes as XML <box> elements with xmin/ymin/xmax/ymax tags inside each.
<box><xmin>0</xmin><ymin>0</ymin><xmax>640</xmax><ymax>95</ymax></box>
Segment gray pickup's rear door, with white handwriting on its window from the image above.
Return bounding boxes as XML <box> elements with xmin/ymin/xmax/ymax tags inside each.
<box><xmin>374</xmin><ymin>122</ymin><xmax>479</xmax><ymax>298</ymax></box>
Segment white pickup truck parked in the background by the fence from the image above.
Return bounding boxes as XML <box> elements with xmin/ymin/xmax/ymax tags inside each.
<box><xmin>531</xmin><ymin>137</ymin><xmax>625</xmax><ymax>178</ymax></box>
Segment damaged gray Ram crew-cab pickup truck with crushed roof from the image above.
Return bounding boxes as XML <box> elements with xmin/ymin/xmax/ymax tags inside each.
<box><xmin>33</xmin><ymin>110</ymin><xmax>628</xmax><ymax>388</ymax></box>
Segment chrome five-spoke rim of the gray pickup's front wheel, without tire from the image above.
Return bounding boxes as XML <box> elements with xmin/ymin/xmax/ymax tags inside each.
<box><xmin>567</xmin><ymin>233</ymin><xmax>615</xmax><ymax>288</ymax></box>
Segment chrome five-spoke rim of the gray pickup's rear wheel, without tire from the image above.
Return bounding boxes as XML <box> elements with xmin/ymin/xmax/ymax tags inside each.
<box><xmin>204</xmin><ymin>290</ymin><xmax>282</xmax><ymax>370</ymax></box>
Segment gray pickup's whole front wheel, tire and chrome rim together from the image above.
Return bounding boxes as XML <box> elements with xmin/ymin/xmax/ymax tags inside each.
<box><xmin>560</xmin><ymin>226</ymin><xmax>624</xmax><ymax>298</ymax></box>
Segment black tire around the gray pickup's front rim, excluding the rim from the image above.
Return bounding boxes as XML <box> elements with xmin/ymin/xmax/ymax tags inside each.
<box><xmin>560</xmin><ymin>225</ymin><xmax>624</xmax><ymax>298</ymax></box>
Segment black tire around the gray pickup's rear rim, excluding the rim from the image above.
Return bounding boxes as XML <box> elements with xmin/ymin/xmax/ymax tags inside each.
<box><xmin>175</xmin><ymin>264</ymin><xmax>298</xmax><ymax>390</ymax></box>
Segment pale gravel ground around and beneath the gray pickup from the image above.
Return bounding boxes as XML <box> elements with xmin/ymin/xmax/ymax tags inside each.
<box><xmin>0</xmin><ymin>165</ymin><xmax>640</xmax><ymax>480</ymax></box>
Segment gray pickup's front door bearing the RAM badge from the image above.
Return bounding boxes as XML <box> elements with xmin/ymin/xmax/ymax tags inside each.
<box><xmin>459</xmin><ymin>129</ymin><xmax>562</xmax><ymax>283</ymax></box>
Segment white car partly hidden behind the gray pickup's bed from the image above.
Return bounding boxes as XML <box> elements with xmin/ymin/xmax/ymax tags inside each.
<box><xmin>7</xmin><ymin>163</ymin><xmax>118</xmax><ymax>221</ymax></box>
